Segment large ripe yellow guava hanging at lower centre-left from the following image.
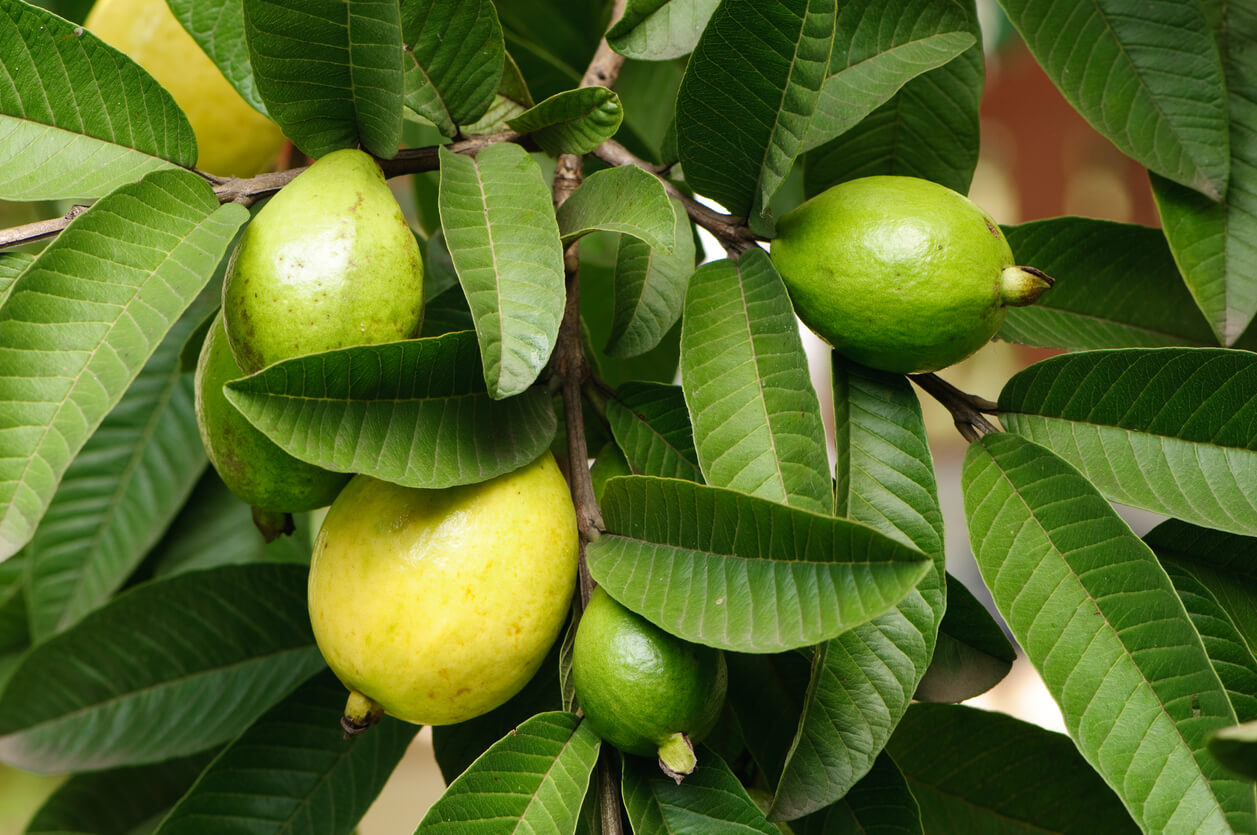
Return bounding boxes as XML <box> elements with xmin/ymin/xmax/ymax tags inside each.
<box><xmin>309</xmin><ymin>451</ymin><xmax>577</xmax><ymax>724</ymax></box>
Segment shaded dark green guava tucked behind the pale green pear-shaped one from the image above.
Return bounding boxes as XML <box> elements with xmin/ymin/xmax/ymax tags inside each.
<box><xmin>195</xmin><ymin>313</ymin><xmax>349</xmax><ymax>513</ymax></box>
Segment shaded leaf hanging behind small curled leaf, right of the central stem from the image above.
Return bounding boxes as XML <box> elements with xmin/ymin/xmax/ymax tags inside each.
<box><xmin>607</xmin><ymin>200</ymin><xmax>695</xmax><ymax>357</ymax></box>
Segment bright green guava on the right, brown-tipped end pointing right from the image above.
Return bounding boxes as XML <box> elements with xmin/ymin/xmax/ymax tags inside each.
<box><xmin>771</xmin><ymin>176</ymin><xmax>1052</xmax><ymax>373</ymax></box>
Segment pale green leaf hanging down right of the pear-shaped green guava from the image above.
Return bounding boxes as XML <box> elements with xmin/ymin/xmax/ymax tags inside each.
<box><xmin>440</xmin><ymin>142</ymin><xmax>564</xmax><ymax>399</ymax></box>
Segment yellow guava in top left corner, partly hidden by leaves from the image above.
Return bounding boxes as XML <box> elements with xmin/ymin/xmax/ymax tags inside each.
<box><xmin>83</xmin><ymin>0</ymin><xmax>284</xmax><ymax>177</ymax></box>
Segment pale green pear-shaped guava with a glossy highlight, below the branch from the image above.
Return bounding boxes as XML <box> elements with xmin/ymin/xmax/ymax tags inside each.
<box><xmin>222</xmin><ymin>150</ymin><xmax>424</xmax><ymax>373</ymax></box>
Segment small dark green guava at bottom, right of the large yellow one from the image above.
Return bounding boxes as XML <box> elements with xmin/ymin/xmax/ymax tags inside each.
<box><xmin>572</xmin><ymin>587</ymin><xmax>728</xmax><ymax>782</ymax></box>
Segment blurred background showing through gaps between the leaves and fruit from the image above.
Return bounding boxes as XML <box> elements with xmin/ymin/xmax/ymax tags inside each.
<box><xmin>0</xmin><ymin>0</ymin><xmax>1159</xmax><ymax>835</ymax></box>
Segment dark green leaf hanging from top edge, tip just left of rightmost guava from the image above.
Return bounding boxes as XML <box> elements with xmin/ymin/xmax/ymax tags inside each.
<box><xmin>676</xmin><ymin>0</ymin><xmax>836</xmax><ymax>216</ymax></box>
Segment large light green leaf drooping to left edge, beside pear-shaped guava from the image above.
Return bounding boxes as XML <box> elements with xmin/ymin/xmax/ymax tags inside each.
<box><xmin>0</xmin><ymin>171</ymin><xmax>249</xmax><ymax>558</ymax></box>
